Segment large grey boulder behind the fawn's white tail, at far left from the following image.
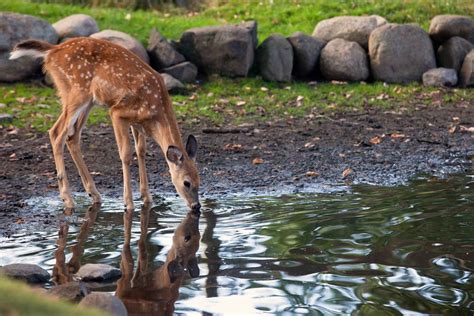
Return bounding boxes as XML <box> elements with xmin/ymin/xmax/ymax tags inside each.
<box><xmin>0</xmin><ymin>12</ymin><xmax>58</xmax><ymax>82</ymax></box>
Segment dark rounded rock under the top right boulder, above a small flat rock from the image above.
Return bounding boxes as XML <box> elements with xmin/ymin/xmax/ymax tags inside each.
<box><xmin>437</xmin><ymin>36</ymin><xmax>473</xmax><ymax>72</ymax></box>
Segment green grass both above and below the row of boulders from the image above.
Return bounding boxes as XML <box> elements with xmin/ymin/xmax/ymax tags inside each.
<box><xmin>0</xmin><ymin>0</ymin><xmax>474</xmax><ymax>131</ymax></box>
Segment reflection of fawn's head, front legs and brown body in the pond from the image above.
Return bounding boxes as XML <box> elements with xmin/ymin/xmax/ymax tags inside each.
<box><xmin>115</xmin><ymin>205</ymin><xmax>201</xmax><ymax>315</ymax></box>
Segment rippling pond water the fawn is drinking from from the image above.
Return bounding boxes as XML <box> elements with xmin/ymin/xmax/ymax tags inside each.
<box><xmin>0</xmin><ymin>174</ymin><xmax>474</xmax><ymax>315</ymax></box>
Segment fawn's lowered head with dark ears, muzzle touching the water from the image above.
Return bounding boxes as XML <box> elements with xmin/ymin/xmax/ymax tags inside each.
<box><xmin>166</xmin><ymin>135</ymin><xmax>201</xmax><ymax>212</ymax></box>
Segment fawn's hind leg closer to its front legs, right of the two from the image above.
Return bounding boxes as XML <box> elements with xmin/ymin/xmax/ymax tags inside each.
<box><xmin>66</xmin><ymin>102</ymin><xmax>101</xmax><ymax>204</ymax></box>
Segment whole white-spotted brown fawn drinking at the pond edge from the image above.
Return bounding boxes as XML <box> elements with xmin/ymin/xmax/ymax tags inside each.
<box><xmin>10</xmin><ymin>38</ymin><xmax>200</xmax><ymax>210</ymax></box>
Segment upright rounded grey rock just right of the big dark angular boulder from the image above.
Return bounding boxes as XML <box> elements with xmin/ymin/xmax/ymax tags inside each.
<box><xmin>257</xmin><ymin>34</ymin><xmax>293</xmax><ymax>82</ymax></box>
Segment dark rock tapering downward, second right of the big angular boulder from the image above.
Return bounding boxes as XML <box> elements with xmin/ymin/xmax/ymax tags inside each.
<box><xmin>288</xmin><ymin>32</ymin><xmax>326</xmax><ymax>78</ymax></box>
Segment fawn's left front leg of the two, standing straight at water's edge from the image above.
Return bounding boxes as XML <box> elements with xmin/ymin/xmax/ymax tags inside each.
<box><xmin>110</xmin><ymin>111</ymin><xmax>134</xmax><ymax>211</ymax></box>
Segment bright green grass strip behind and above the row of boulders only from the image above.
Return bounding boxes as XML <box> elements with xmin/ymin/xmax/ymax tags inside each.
<box><xmin>0</xmin><ymin>0</ymin><xmax>474</xmax><ymax>44</ymax></box>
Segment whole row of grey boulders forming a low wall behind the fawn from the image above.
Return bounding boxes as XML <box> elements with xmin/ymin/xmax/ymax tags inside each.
<box><xmin>0</xmin><ymin>12</ymin><xmax>474</xmax><ymax>89</ymax></box>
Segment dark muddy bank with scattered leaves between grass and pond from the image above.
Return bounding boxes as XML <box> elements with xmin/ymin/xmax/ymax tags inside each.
<box><xmin>0</xmin><ymin>101</ymin><xmax>474</xmax><ymax>234</ymax></box>
